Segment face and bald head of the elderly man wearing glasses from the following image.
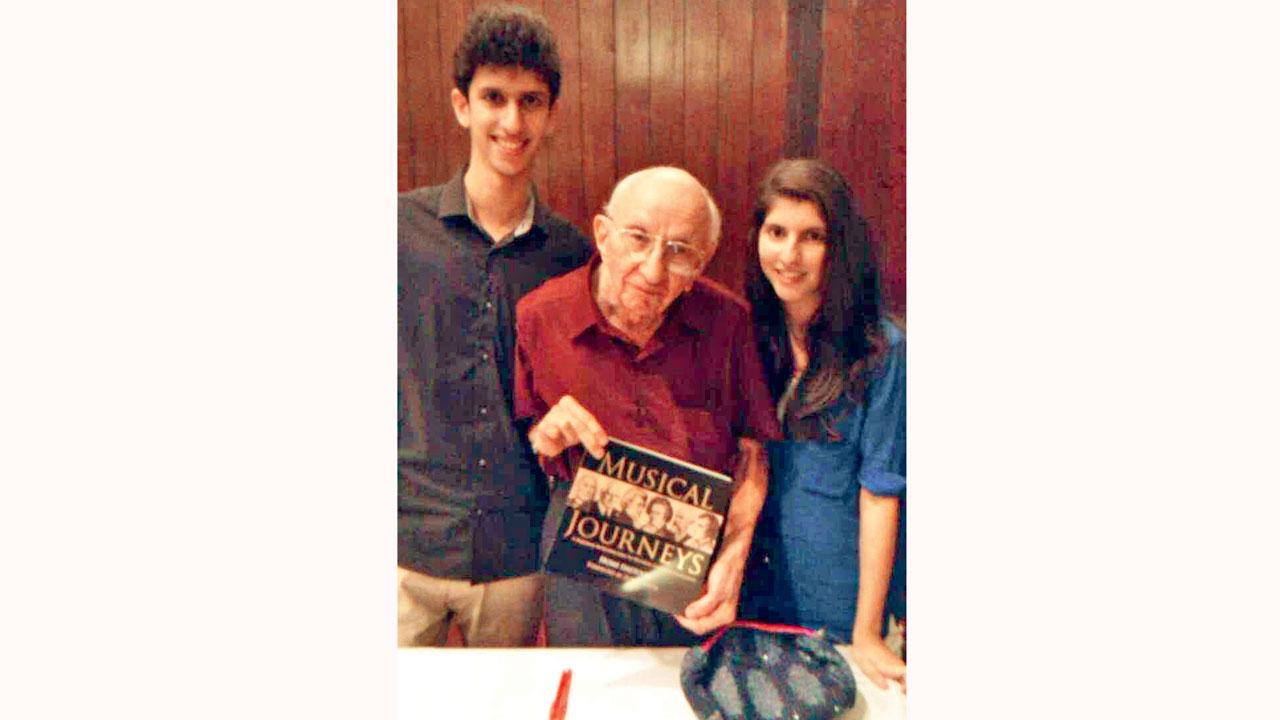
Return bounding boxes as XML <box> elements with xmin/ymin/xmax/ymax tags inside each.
<box><xmin>593</xmin><ymin>169</ymin><xmax>714</xmax><ymax>338</ymax></box>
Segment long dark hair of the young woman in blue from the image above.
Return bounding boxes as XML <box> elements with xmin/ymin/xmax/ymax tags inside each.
<box><xmin>746</xmin><ymin>159</ymin><xmax>884</xmax><ymax>439</ymax></box>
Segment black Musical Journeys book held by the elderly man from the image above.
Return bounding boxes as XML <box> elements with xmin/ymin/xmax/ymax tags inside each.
<box><xmin>544</xmin><ymin>437</ymin><xmax>733</xmax><ymax>615</ymax></box>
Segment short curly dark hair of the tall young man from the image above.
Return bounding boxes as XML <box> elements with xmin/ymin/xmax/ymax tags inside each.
<box><xmin>453</xmin><ymin>5</ymin><xmax>561</xmax><ymax>105</ymax></box>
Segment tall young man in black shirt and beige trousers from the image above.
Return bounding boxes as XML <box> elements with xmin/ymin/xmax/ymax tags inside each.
<box><xmin>398</xmin><ymin>6</ymin><xmax>591</xmax><ymax>647</ymax></box>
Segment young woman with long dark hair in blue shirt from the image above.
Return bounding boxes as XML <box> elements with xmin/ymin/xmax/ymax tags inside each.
<box><xmin>744</xmin><ymin>159</ymin><xmax>906</xmax><ymax>687</ymax></box>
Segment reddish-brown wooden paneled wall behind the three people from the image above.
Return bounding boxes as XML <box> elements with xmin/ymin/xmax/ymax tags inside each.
<box><xmin>399</xmin><ymin>0</ymin><xmax>906</xmax><ymax>314</ymax></box>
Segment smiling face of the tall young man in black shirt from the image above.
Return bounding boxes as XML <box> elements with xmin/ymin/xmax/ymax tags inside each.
<box><xmin>451</xmin><ymin>65</ymin><xmax>554</xmax><ymax>179</ymax></box>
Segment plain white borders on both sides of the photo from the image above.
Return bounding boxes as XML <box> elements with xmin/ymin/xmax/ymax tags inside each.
<box><xmin>0</xmin><ymin>1</ymin><xmax>1280</xmax><ymax>719</ymax></box>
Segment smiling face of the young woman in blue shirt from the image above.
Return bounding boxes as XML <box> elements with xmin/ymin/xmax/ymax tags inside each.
<box><xmin>758</xmin><ymin>196</ymin><xmax>827</xmax><ymax>316</ymax></box>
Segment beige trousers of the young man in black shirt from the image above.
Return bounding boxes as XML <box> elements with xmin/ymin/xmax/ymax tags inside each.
<box><xmin>397</xmin><ymin>568</ymin><xmax>543</xmax><ymax>647</ymax></box>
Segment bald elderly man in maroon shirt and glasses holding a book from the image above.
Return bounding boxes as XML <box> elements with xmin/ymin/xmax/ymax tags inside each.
<box><xmin>515</xmin><ymin>168</ymin><xmax>780</xmax><ymax>646</ymax></box>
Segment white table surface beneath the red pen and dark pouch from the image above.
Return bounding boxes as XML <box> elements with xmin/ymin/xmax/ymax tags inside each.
<box><xmin>396</xmin><ymin>646</ymin><xmax>906</xmax><ymax>720</ymax></box>
